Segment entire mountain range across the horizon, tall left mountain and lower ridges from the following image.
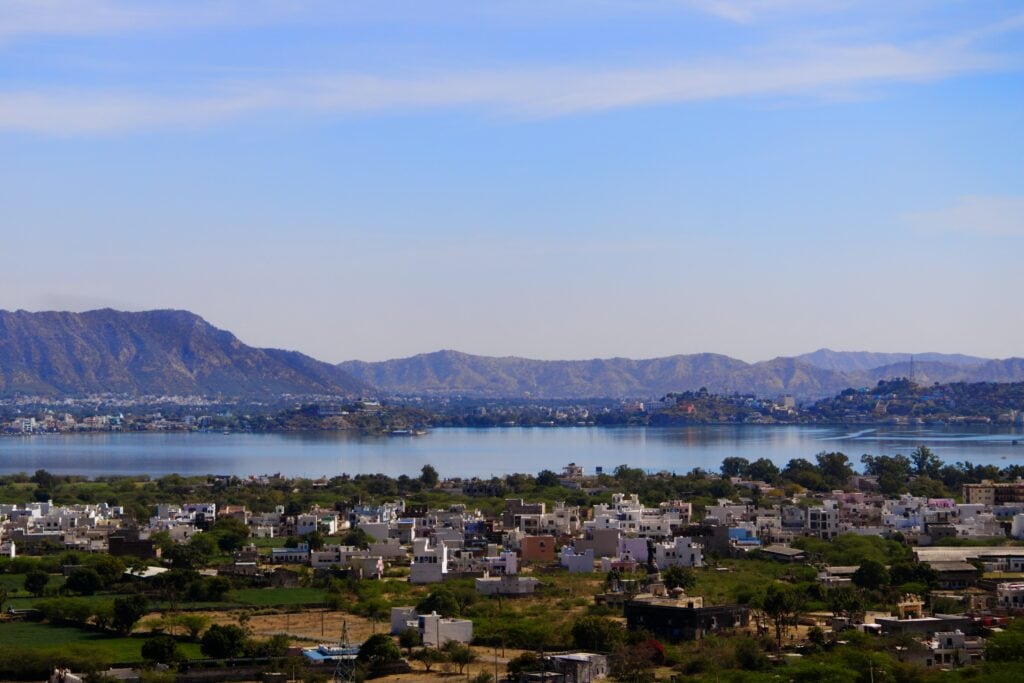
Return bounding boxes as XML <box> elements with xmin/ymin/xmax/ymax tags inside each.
<box><xmin>0</xmin><ymin>309</ymin><xmax>1024</xmax><ymax>398</ymax></box>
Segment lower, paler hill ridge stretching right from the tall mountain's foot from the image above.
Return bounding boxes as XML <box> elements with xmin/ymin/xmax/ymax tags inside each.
<box><xmin>339</xmin><ymin>349</ymin><xmax>1024</xmax><ymax>398</ymax></box>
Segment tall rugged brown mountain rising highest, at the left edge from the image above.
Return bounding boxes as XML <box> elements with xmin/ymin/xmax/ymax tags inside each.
<box><xmin>0</xmin><ymin>309</ymin><xmax>367</xmax><ymax>397</ymax></box>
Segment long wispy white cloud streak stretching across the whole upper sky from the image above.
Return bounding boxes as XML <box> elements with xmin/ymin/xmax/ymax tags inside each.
<box><xmin>0</xmin><ymin>35</ymin><xmax>1020</xmax><ymax>134</ymax></box>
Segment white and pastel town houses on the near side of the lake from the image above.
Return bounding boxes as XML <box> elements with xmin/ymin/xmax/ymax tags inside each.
<box><xmin>9</xmin><ymin>466</ymin><xmax>1024</xmax><ymax>666</ymax></box>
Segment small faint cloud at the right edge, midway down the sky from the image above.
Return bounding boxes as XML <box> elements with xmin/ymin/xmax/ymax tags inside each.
<box><xmin>905</xmin><ymin>195</ymin><xmax>1024</xmax><ymax>236</ymax></box>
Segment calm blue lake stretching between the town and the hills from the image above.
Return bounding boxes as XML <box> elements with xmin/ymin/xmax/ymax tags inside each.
<box><xmin>0</xmin><ymin>425</ymin><xmax>1024</xmax><ymax>477</ymax></box>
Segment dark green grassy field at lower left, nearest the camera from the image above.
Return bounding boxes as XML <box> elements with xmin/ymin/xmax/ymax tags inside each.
<box><xmin>0</xmin><ymin>622</ymin><xmax>201</xmax><ymax>661</ymax></box>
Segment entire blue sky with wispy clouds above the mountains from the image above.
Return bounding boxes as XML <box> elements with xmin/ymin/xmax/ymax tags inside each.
<box><xmin>0</xmin><ymin>0</ymin><xmax>1024</xmax><ymax>361</ymax></box>
